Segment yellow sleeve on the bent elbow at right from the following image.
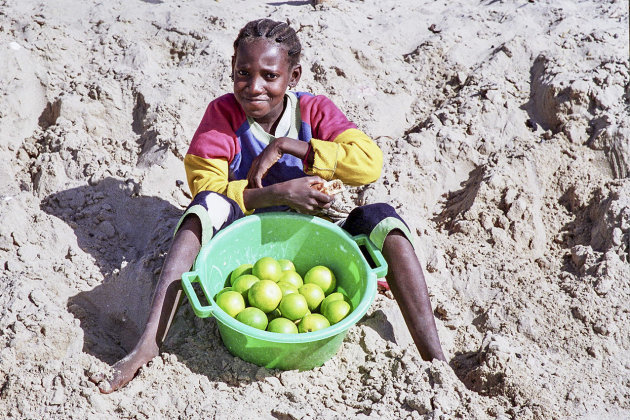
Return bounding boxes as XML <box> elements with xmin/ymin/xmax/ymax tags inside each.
<box><xmin>306</xmin><ymin>128</ymin><xmax>383</xmax><ymax>185</ymax></box>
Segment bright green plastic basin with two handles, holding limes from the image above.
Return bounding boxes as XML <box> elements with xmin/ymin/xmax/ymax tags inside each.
<box><xmin>182</xmin><ymin>213</ymin><xmax>387</xmax><ymax>370</ymax></box>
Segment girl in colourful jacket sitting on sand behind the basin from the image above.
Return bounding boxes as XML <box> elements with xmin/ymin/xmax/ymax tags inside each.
<box><xmin>90</xmin><ymin>19</ymin><xmax>445</xmax><ymax>393</ymax></box>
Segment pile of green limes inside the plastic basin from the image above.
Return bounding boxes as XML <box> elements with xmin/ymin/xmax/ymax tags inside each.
<box><xmin>215</xmin><ymin>257</ymin><xmax>352</xmax><ymax>334</ymax></box>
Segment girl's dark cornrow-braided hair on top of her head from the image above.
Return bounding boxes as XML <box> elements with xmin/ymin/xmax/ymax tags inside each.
<box><xmin>234</xmin><ymin>19</ymin><xmax>302</xmax><ymax>67</ymax></box>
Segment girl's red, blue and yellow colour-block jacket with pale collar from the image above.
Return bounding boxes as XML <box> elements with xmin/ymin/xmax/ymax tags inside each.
<box><xmin>184</xmin><ymin>92</ymin><xmax>383</xmax><ymax>213</ymax></box>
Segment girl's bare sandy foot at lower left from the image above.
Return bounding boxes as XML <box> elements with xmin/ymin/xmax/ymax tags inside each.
<box><xmin>90</xmin><ymin>345</ymin><xmax>159</xmax><ymax>394</ymax></box>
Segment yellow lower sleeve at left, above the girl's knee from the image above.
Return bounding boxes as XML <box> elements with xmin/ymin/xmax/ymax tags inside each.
<box><xmin>184</xmin><ymin>154</ymin><xmax>254</xmax><ymax>214</ymax></box>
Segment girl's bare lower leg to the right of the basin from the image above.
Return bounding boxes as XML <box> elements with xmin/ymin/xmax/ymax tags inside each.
<box><xmin>383</xmin><ymin>230</ymin><xmax>446</xmax><ymax>361</ymax></box>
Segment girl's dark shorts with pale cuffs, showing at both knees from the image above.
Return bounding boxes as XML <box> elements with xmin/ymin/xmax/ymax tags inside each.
<box><xmin>175</xmin><ymin>191</ymin><xmax>413</xmax><ymax>250</ymax></box>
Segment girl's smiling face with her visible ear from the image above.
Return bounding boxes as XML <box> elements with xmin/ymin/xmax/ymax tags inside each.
<box><xmin>232</xmin><ymin>39</ymin><xmax>302</xmax><ymax>132</ymax></box>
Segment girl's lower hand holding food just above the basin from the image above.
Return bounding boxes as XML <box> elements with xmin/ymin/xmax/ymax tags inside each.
<box><xmin>274</xmin><ymin>176</ymin><xmax>333</xmax><ymax>214</ymax></box>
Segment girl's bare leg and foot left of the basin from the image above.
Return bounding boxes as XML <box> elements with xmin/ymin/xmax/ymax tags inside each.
<box><xmin>90</xmin><ymin>215</ymin><xmax>201</xmax><ymax>394</ymax></box>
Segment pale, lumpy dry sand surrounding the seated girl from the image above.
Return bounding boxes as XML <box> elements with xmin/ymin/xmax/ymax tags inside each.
<box><xmin>0</xmin><ymin>0</ymin><xmax>630</xmax><ymax>419</ymax></box>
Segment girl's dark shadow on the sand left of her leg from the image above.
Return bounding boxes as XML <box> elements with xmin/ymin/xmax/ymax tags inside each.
<box><xmin>42</xmin><ymin>178</ymin><xmax>182</xmax><ymax>363</ymax></box>
